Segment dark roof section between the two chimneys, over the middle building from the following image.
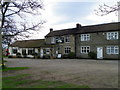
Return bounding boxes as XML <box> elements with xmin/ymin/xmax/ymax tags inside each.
<box><xmin>45</xmin><ymin>28</ymin><xmax>76</xmax><ymax>37</ymax></box>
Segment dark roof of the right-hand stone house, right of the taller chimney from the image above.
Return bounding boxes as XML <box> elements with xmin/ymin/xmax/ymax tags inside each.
<box><xmin>76</xmin><ymin>22</ymin><xmax>120</xmax><ymax>34</ymax></box>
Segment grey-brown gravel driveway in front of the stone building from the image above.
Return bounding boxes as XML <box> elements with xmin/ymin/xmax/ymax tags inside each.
<box><xmin>3</xmin><ymin>58</ymin><xmax>118</xmax><ymax>88</ymax></box>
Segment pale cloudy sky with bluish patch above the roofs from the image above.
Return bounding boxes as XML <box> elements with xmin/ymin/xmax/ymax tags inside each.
<box><xmin>28</xmin><ymin>0</ymin><xmax>119</xmax><ymax>39</ymax></box>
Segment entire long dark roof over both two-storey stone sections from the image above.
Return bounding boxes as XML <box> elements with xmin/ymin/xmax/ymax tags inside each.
<box><xmin>45</xmin><ymin>22</ymin><xmax>120</xmax><ymax>37</ymax></box>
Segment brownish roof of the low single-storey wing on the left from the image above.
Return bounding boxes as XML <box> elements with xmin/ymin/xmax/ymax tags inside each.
<box><xmin>10</xmin><ymin>39</ymin><xmax>50</xmax><ymax>48</ymax></box>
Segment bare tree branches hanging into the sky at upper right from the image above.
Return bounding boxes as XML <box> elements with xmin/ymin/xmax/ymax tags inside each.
<box><xmin>95</xmin><ymin>2</ymin><xmax>120</xmax><ymax>16</ymax></box>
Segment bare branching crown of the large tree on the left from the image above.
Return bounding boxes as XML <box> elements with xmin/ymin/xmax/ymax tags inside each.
<box><xmin>0</xmin><ymin>0</ymin><xmax>45</xmax><ymax>68</ymax></box>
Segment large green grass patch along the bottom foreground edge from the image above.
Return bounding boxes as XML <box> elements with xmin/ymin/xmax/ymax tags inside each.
<box><xmin>2</xmin><ymin>74</ymin><xmax>89</xmax><ymax>88</ymax></box>
